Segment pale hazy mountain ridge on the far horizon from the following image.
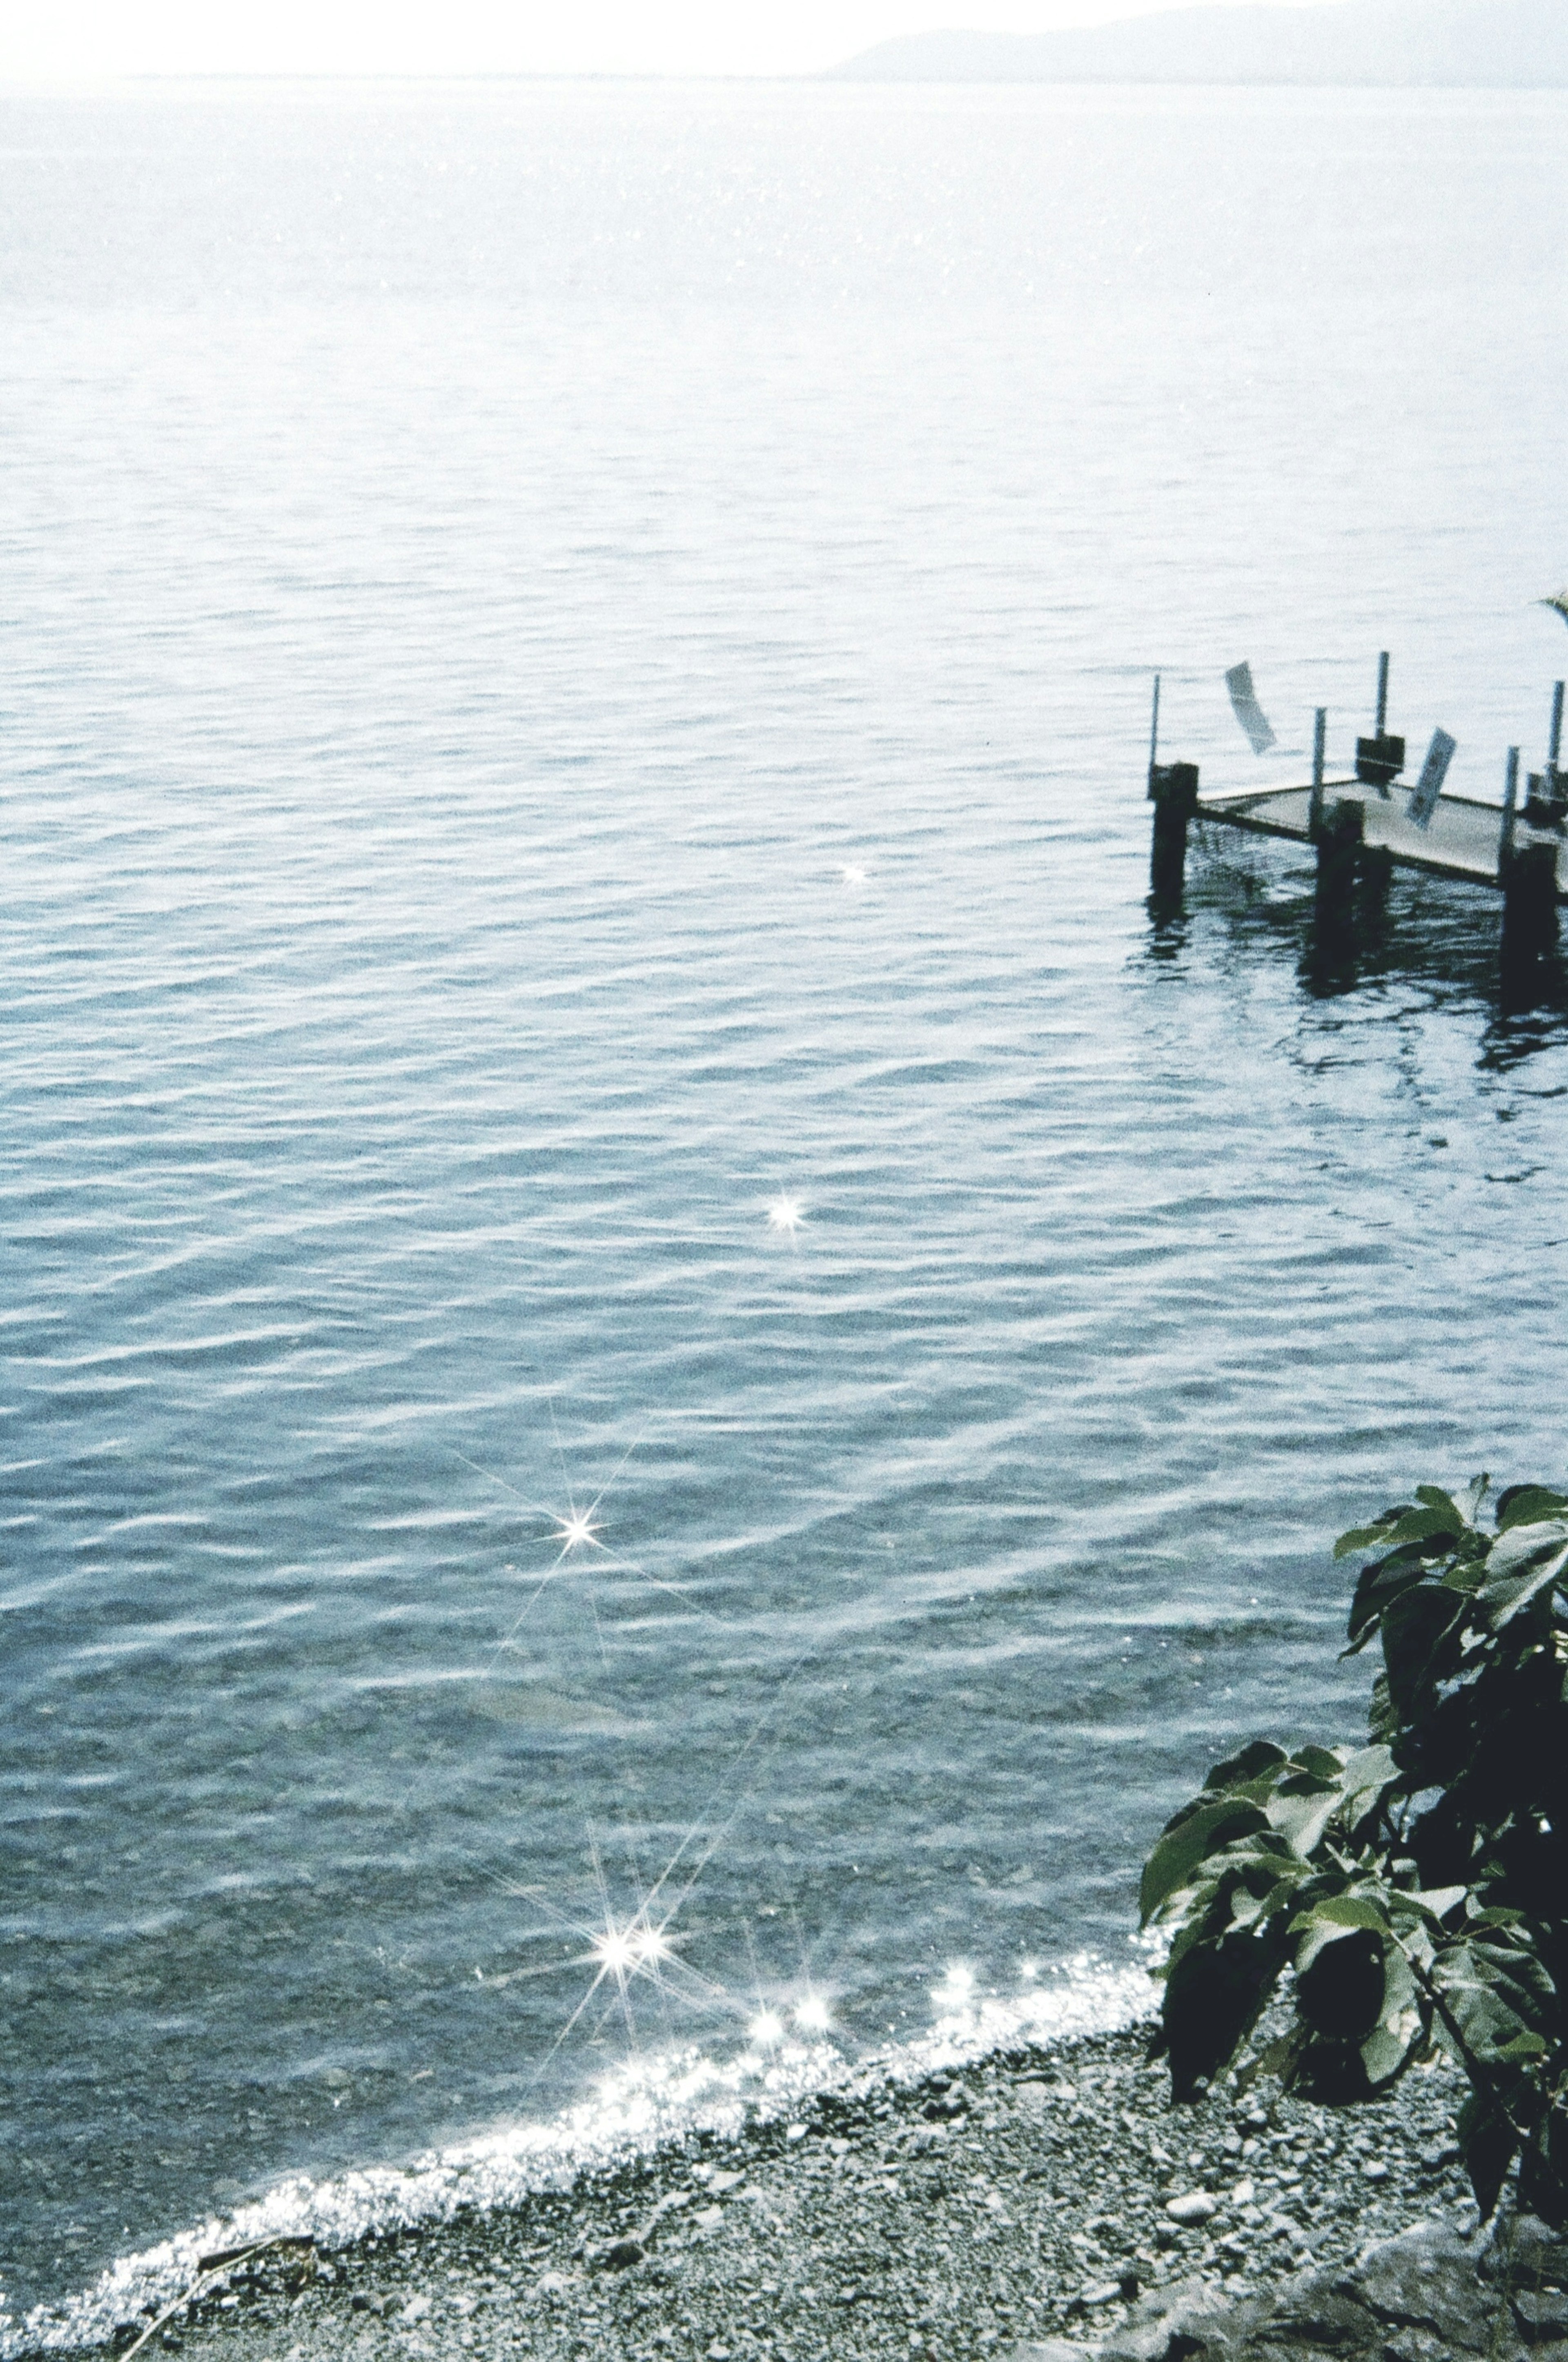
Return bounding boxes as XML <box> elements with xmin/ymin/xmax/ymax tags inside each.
<box><xmin>831</xmin><ymin>0</ymin><xmax>1568</xmax><ymax>90</ymax></box>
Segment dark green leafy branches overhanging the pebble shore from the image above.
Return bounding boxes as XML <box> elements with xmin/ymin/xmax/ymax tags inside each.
<box><xmin>1140</xmin><ymin>1476</ymin><xmax>1568</xmax><ymax>2223</ymax></box>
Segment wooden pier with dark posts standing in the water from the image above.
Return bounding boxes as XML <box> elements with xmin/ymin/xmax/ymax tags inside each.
<box><xmin>1148</xmin><ymin>657</ymin><xmax>1568</xmax><ymax>954</ymax></box>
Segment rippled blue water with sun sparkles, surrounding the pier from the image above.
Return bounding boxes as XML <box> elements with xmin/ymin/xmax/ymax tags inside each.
<box><xmin>0</xmin><ymin>69</ymin><xmax>1568</xmax><ymax>2346</ymax></box>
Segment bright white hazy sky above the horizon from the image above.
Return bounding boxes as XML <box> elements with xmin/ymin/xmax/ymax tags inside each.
<box><xmin>0</xmin><ymin>0</ymin><xmax>1350</xmax><ymax>80</ymax></box>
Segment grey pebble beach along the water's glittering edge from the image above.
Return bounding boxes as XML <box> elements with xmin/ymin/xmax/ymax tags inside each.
<box><xmin>82</xmin><ymin>2027</ymin><xmax>1476</xmax><ymax>2362</ymax></box>
